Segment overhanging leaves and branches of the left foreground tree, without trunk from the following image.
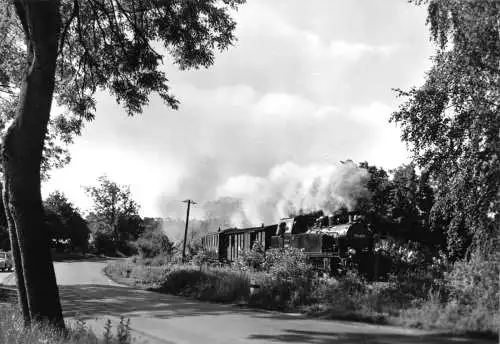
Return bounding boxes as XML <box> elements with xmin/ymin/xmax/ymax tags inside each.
<box><xmin>0</xmin><ymin>0</ymin><xmax>244</xmax><ymax>127</ymax></box>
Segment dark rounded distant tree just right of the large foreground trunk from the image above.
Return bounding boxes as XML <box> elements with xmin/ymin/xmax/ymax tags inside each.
<box><xmin>44</xmin><ymin>191</ymin><xmax>90</xmax><ymax>251</ymax></box>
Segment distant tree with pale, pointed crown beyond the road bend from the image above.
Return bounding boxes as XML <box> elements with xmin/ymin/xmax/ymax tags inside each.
<box><xmin>85</xmin><ymin>176</ymin><xmax>142</xmax><ymax>245</ymax></box>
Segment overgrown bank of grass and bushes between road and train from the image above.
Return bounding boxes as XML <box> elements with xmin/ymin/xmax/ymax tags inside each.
<box><xmin>104</xmin><ymin>250</ymin><xmax>500</xmax><ymax>338</ymax></box>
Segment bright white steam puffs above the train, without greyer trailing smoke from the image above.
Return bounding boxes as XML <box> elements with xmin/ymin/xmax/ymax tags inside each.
<box><xmin>213</xmin><ymin>161</ymin><xmax>369</xmax><ymax>227</ymax></box>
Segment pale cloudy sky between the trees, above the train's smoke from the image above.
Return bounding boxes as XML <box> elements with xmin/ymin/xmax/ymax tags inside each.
<box><xmin>42</xmin><ymin>0</ymin><xmax>432</xmax><ymax>217</ymax></box>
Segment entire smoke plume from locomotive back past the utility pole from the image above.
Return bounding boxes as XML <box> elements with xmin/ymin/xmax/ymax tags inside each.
<box><xmin>158</xmin><ymin>160</ymin><xmax>369</xmax><ymax>234</ymax></box>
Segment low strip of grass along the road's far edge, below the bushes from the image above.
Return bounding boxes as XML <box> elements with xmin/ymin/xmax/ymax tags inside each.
<box><xmin>105</xmin><ymin>258</ymin><xmax>499</xmax><ymax>338</ymax></box>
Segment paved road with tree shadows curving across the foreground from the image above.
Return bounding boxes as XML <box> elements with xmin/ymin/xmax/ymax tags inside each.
<box><xmin>0</xmin><ymin>261</ymin><xmax>491</xmax><ymax>344</ymax></box>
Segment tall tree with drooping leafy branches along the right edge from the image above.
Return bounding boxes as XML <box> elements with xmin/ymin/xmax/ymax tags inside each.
<box><xmin>391</xmin><ymin>0</ymin><xmax>500</xmax><ymax>259</ymax></box>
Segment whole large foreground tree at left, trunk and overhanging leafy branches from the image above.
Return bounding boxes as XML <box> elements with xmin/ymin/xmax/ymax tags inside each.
<box><xmin>0</xmin><ymin>0</ymin><xmax>243</xmax><ymax>328</ymax></box>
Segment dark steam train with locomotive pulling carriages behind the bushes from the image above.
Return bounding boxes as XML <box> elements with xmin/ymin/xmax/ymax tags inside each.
<box><xmin>201</xmin><ymin>211</ymin><xmax>373</xmax><ymax>274</ymax></box>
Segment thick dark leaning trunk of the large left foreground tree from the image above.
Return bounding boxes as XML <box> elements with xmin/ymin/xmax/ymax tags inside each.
<box><xmin>2</xmin><ymin>0</ymin><xmax>64</xmax><ymax>328</ymax></box>
